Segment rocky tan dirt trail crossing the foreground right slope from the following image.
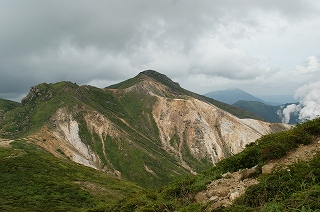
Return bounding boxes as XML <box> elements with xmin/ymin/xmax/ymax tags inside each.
<box><xmin>195</xmin><ymin>138</ymin><xmax>320</xmax><ymax>209</ymax></box>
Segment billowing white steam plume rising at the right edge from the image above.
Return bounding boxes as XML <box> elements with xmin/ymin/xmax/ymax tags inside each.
<box><xmin>282</xmin><ymin>81</ymin><xmax>320</xmax><ymax>123</ymax></box>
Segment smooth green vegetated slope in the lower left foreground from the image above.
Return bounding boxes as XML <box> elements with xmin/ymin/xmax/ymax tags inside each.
<box><xmin>0</xmin><ymin>140</ymin><xmax>141</xmax><ymax>211</ymax></box>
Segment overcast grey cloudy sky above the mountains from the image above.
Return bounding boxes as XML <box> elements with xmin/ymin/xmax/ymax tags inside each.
<box><xmin>0</xmin><ymin>0</ymin><xmax>320</xmax><ymax>101</ymax></box>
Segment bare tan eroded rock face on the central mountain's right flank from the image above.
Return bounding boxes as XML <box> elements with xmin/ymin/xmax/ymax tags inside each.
<box><xmin>153</xmin><ymin>96</ymin><xmax>288</xmax><ymax>164</ymax></box>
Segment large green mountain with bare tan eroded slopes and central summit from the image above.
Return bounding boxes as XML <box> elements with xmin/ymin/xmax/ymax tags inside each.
<box><xmin>0</xmin><ymin>70</ymin><xmax>289</xmax><ymax>188</ymax></box>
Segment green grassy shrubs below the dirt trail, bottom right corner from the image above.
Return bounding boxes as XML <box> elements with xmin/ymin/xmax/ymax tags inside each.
<box><xmin>233</xmin><ymin>153</ymin><xmax>320</xmax><ymax>211</ymax></box>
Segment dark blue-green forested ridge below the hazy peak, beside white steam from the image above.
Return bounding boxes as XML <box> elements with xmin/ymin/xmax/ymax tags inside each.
<box><xmin>232</xmin><ymin>100</ymin><xmax>299</xmax><ymax>124</ymax></box>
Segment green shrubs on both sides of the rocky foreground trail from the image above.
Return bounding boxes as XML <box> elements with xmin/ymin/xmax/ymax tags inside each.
<box><xmin>108</xmin><ymin>118</ymin><xmax>320</xmax><ymax>211</ymax></box>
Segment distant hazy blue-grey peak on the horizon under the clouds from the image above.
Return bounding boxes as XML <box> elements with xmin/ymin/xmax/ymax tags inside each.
<box><xmin>204</xmin><ymin>88</ymin><xmax>264</xmax><ymax>105</ymax></box>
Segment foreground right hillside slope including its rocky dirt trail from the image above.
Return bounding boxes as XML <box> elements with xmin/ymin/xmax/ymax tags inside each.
<box><xmin>107</xmin><ymin>118</ymin><xmax>320</xmax><ymax>212</ymax></box>
